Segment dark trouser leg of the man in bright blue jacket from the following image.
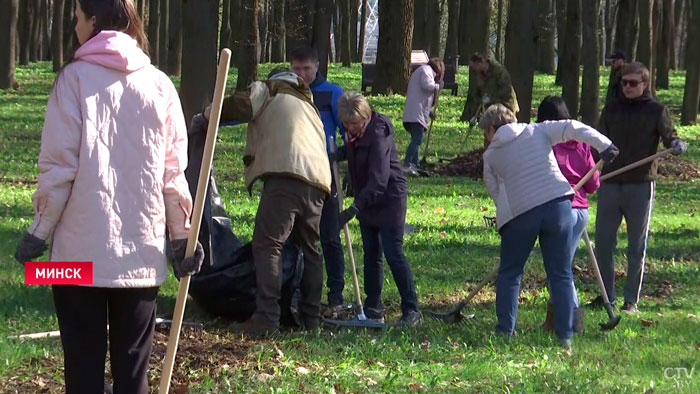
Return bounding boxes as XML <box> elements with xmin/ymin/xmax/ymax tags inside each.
<box><xmin>320</xmin><ymin>180</ymin><xmax>345</xmax><ymax>305</ymax></box>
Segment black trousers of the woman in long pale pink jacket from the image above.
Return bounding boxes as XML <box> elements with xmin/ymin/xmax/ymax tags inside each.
<box><xmin>53</xmin><ymin>285</ymin><xmax>158</xmax><ymax>394</ymax></box>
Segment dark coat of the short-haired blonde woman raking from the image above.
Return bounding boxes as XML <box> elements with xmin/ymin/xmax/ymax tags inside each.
<box><xmin>338</xmin><ymin>112</ymin><xmax>407</xmax><ymax>226</ymax></box>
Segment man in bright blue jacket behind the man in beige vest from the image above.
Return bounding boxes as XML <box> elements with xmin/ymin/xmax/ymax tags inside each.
<box><xmin>290</xmin><ymin>46</ymin><xmax>345</xmax><ymax>307</ymax></box>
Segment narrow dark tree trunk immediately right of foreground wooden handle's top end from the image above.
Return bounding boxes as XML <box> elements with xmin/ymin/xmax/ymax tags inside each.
<box><xmin>236</xmin><ymin>0</ymin><xmax>260</xmax><ymax>90</ymax></box>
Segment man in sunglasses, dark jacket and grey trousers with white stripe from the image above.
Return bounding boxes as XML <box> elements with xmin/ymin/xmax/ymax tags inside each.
<box><xmin>590</xmin><ymin>63</ymin><xmax>687</xmax><ymax>313</ymax></box>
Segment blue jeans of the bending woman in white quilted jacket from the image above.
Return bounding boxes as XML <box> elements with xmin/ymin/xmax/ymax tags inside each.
<box><xmin>496</xmin><ymin>197</ymin><xmax>576</xmax><ymax>339</ymax></box>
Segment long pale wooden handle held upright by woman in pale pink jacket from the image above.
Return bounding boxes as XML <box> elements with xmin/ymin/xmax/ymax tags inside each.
<box><xmin>158</xmin><ymin>48</ymin><xmax>231</xmax><ymax>394</ymax></box>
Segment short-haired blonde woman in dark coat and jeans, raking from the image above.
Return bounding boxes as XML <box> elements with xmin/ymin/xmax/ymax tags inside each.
<box><xmin>331</xmin><ymin>92</ymin><xmax>421</xmax><ymax>325</ymax></box>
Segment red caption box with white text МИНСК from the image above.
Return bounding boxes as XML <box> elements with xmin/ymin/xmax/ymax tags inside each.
<box><xmin>24</xmin><ymin>261</ymin><xmax>92</xmax><ymax>285</ymax></box>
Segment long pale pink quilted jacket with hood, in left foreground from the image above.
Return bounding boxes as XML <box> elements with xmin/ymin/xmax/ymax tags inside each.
<box><xmin>28</xmin><ymin>31</ymin><xmax>192</xmax><ymax>287</ymax></box>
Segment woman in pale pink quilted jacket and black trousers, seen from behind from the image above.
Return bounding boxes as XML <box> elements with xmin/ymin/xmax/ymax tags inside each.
<box><xmin>15</xmin><ymin>0</ymin><xmax>203</xmax><ymax>393</ymax></box>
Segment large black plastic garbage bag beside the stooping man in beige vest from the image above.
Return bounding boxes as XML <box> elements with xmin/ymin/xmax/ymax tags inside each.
<box><xmin>180</xmin><ymin>115</ymin><xmax>304</xmax><ymax>325</ymax></box>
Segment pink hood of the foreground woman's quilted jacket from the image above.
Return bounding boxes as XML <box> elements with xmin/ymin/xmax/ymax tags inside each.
<box><xmin>75</xmin><ymin>30</ymin><xmax>151</xmax><ymax>73</ymax></box>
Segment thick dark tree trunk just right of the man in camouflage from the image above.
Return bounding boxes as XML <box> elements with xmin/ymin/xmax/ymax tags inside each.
<box><xmin>505</xmin><ymin>0</ymin><xmax>537</xmax><ymax>123</ymax></box>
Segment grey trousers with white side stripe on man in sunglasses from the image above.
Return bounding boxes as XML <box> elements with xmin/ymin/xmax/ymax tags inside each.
<box><xmin>595</xmin><ymin>182</ymin><xmax>654</xmax><ymax>303</ymax></box>
